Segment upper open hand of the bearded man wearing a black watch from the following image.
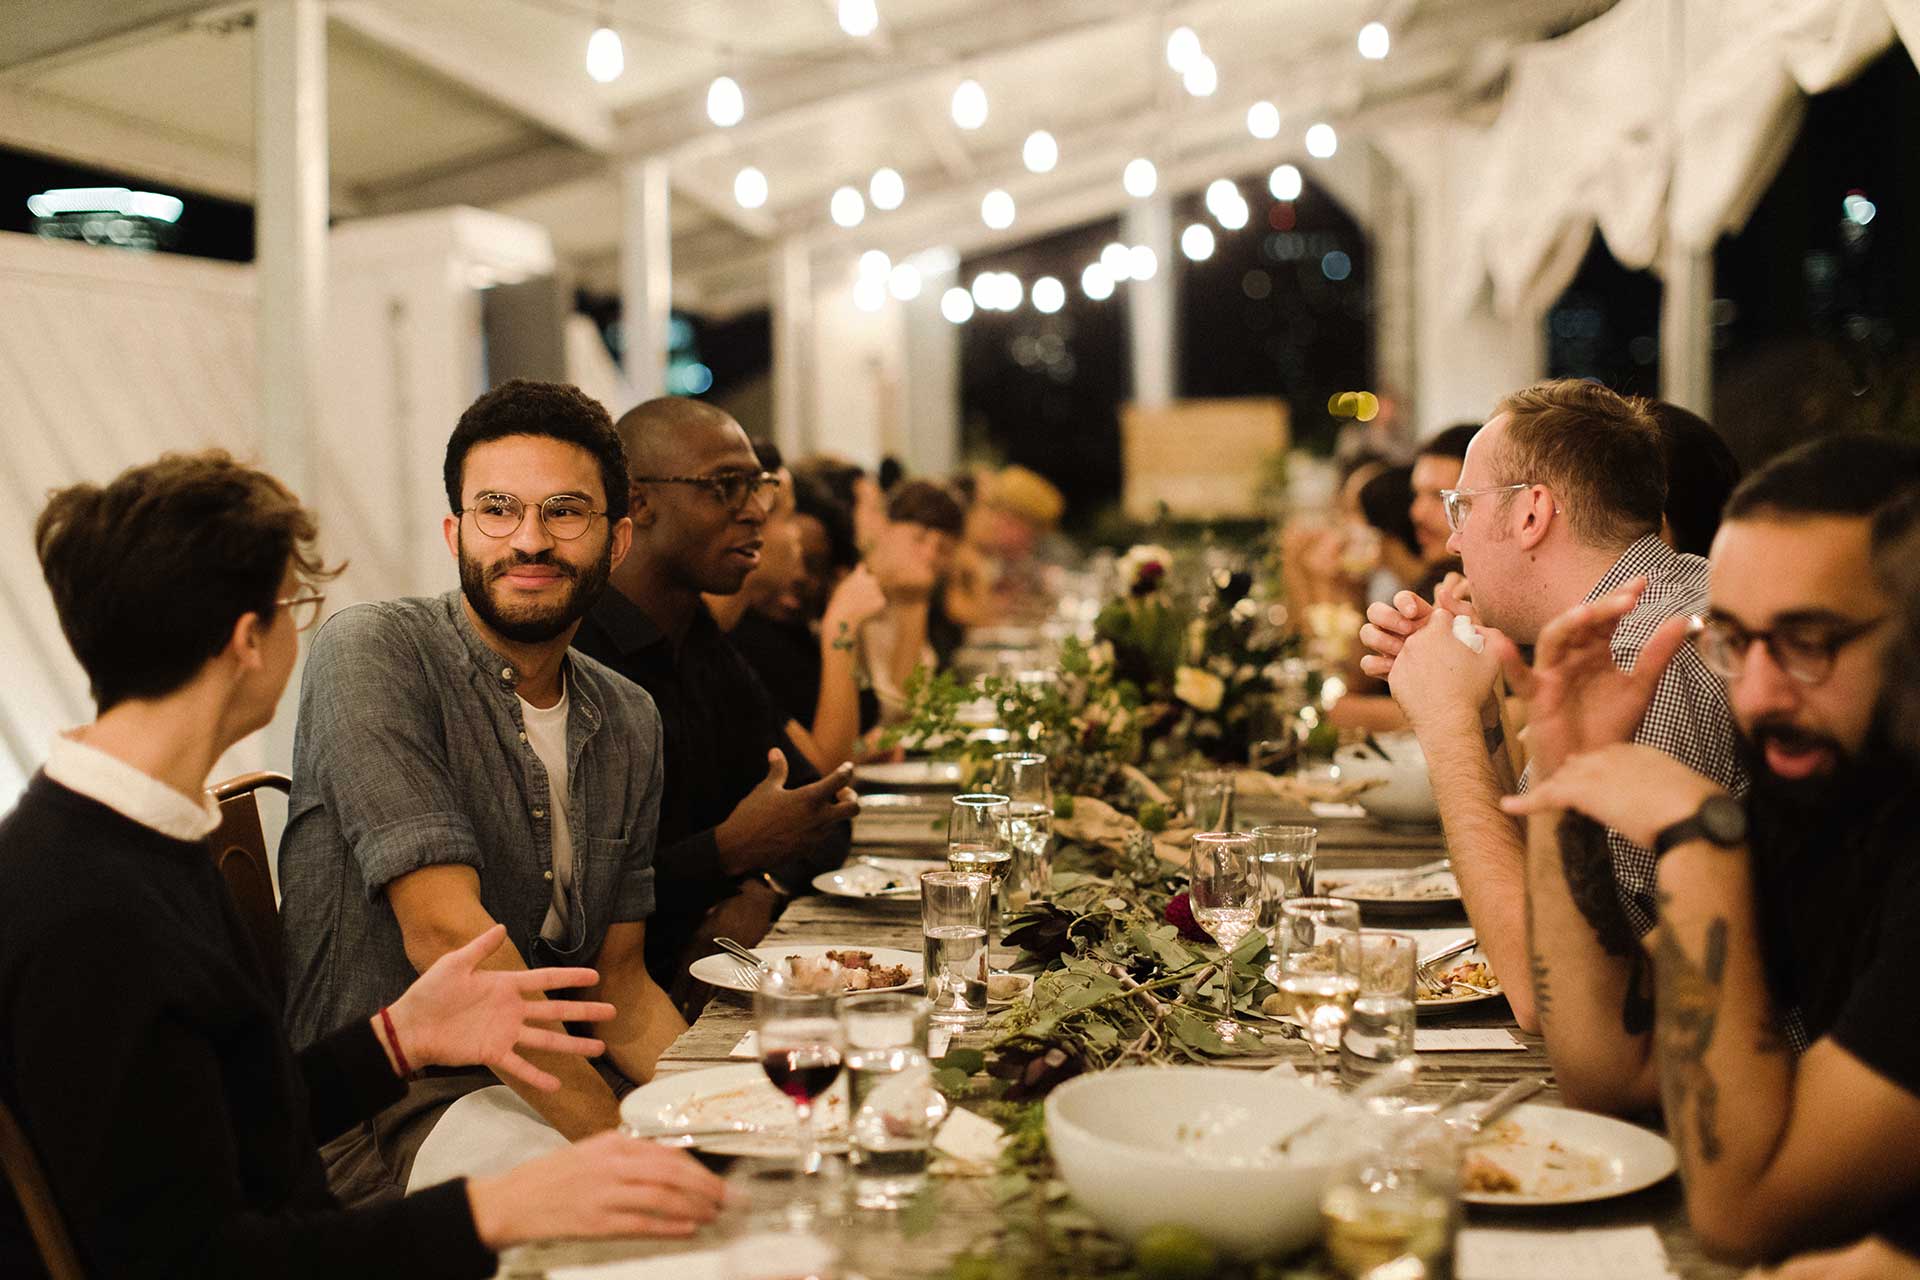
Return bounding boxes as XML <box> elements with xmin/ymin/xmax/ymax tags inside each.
<box><xmin>1488</xmin><ymin>578</ymin><xmax>1688</xmax><ymax>777</ymax></box>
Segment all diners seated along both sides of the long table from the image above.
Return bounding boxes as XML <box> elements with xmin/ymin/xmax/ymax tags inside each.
<box><xmin>0</xmin><ymin>372</ymin><xmax>1920</xmax><ymax>1276</ymax></box>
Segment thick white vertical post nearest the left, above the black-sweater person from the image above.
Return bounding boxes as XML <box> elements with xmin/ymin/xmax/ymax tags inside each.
<box><xmin>253</xmin><ymin>0</ymin><xmax>326</xmax><ymax>501</ymax></box>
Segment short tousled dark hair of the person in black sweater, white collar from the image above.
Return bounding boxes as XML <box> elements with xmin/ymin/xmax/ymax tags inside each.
<box><xmin>33</xmin><ymin>449</ymin><xmax>340</xmax><ymax>712</ymax></box>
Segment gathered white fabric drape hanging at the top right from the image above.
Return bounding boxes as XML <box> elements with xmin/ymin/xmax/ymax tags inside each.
<box><xmin>1452</xmin><ymin>0</ymin><xmax>1920</xmax><ymax>315</ymax></box>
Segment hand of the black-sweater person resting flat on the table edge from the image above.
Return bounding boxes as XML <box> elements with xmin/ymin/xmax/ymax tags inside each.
<box><xmin>467</xmin><ymin>1130</ymin><xmax>726</xmax><ymax>1249</ymax></box>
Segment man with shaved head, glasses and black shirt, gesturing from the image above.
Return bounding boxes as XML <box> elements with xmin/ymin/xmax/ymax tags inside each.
<box><xmin>574</xmin><ymin>397</ymin><xmax>858</xmax><ymax>1015</ymax></box>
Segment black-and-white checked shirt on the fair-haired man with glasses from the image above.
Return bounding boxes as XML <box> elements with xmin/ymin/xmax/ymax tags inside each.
<box><xmin>1521</xmin><ymin>533</ymin><xmax>1747</xmax><ymax>935</ymax></box>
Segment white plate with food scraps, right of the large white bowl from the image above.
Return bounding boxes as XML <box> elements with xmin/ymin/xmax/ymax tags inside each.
<box><xmin>1459</xmin><ymin>1103</ymin><xmax>1676</xmax><ymax>1205</ymax></box>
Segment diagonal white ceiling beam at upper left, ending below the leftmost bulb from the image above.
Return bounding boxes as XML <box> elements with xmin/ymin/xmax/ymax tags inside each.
<box><xmin>328</xmin><ymin>0</ymin><xmax>616</xmax><ymax>154</ymax></box>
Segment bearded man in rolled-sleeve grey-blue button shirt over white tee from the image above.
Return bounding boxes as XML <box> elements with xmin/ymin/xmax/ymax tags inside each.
<box><xmin>280</xmin><ymin>380</ymin><xmax>685</xmax><ymax>1203</ymax></box>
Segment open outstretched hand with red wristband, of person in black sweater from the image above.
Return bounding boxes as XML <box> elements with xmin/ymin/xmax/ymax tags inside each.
<box><xmin>388</xmin><ymin>925</ymin><xmax>614</xmax><ymax>1092</ymax></box>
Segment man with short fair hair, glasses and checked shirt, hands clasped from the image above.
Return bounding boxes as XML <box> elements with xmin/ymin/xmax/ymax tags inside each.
<box><xmin>1361</xmin><ymin>380</ymin><xmax>1745</xmax><ymax>1043</ymax></box>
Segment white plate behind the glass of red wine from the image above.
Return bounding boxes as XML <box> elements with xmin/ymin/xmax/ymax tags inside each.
<box><xmin>620</xmin><ymin>1063</ymin><xmax>847</xmax><ymax>1155</ymax></box>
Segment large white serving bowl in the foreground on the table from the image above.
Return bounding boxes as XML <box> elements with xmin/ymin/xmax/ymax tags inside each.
<box><xmin>1046</xmin><ymin>1067</ymin><xmax>1350</xmax><ymax>1257</ymax></box>
